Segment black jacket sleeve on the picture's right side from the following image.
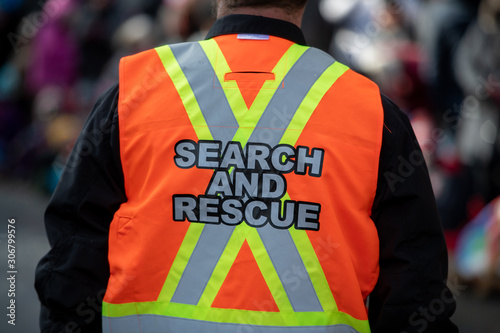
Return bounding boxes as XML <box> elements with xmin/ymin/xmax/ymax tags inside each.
<box><xmin>368</xmin><ymin>96</ymin><xmax>458</xmax><ymax>333</ymax></box>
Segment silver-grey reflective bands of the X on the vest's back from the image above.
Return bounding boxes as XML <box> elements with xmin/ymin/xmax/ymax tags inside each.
<box><xmin>171</xmin><ymin>43</ymin><xmax>334</xmax><ymax>312</ymax></box>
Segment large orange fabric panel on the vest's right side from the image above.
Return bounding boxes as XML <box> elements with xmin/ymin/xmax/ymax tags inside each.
<box><xmin>287</xmin><ymin>70</ymin><xmax>383</xmax><ymax>319</ymax></box>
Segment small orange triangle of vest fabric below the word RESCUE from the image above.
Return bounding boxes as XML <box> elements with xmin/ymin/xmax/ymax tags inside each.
<box><xmin>212</xmin><ymin>241</ymin><xmax>279</xmax><ymax>312</ymax></box>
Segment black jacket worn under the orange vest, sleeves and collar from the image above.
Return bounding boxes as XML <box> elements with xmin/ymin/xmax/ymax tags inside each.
<box><xmin>35</xmin><ymin>15</ymin><xmax>458</xmax><ymax>333</ymax></box>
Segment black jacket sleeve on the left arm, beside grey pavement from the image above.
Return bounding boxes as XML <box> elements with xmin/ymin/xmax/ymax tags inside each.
<box><xmin>35</xmin><ymin>85</ymin><xmax>126</xmax><ymax>333</ymax></box>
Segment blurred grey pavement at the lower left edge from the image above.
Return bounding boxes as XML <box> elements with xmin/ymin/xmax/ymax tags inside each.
<box><xmin>0</xmin><ymin>183</ymin><xmax>49</xmax><ymax>333</ymax></box>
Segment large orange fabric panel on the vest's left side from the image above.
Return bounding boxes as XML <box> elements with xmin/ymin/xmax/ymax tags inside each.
<box><xmin>104</xmin><ymin>51</ymin><xmax>215</xmax><ymax>303</ymax></box>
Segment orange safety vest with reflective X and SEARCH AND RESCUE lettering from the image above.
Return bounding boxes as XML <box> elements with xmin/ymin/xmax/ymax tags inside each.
<box><xmin>103</xmin><ymin>35</ymin><xmax>383</xmax><ymax>333</ymax></box>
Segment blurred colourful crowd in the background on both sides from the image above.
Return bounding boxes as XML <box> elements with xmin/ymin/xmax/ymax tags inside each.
<box><xmin>0</xmin><ymin>0</ymin><xmax>500</xmax><ymax>300</ymax></box>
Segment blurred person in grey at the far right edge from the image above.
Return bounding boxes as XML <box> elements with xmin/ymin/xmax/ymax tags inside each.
<box><xmin>454</xmin><ymin>0</ymin><xmax>500</xmax><ymax>202</ymax></box>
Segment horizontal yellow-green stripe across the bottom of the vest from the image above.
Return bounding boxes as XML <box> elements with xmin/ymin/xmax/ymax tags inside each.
<box><xmin>103</xmin><ymin>302</ymin><xmax>370</xmax><ymax>333</ymax></box>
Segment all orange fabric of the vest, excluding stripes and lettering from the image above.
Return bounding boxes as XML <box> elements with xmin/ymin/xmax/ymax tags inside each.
<box><xmin>105</xmin><ymin>35</ymin><xmax>383</xmax><ymax>319</ymax></box>
